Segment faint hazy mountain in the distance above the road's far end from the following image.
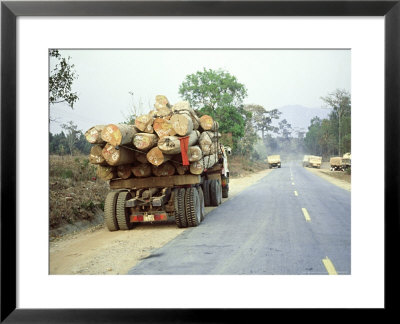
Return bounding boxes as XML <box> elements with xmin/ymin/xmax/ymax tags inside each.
<box><xmin>273</xmin><ymin>105</ymin><xmax>330</xmax><ymax>132</ymax></box>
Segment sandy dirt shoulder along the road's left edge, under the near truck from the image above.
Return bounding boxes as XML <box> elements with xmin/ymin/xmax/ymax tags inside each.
<box><xmin>49</xmin><ymin>169</ymin><xmax>272</xmax><ymax>275</ymax></box>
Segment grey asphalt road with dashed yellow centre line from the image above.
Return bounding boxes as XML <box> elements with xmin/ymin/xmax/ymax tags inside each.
<box><xmin>128</xmin><ymin>162</ymin><xmax>351</xmax><ymax>275</ymax></box>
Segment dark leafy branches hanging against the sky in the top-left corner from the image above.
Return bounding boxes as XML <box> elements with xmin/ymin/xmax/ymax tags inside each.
<box><xmin>49</xmin><ymin>49</ymin><xmax>79</xmax><ymax>108</ymax></box>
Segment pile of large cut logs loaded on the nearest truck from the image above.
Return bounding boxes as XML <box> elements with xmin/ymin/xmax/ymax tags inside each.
<box><xmin>85</xmin><ymin>95</ymin><xmax>221</xmax><ymax>180</ymax></box>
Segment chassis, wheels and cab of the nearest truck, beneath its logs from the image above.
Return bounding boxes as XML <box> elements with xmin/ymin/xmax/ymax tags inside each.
<box><xmin>104</xmin><ymin>144</ymin><xmax>230</xmax><ymax>231</ymax></box>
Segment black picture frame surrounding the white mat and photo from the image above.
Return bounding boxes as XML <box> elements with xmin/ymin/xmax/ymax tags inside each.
<box><xmin>1</xmin><ymin>0</ymin><xmax>400</xmax><ymax>323</ymax></box>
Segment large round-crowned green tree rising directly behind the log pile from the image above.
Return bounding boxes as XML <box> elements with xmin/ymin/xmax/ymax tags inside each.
<box><xmin>179</xmin><ymin>69</ymin><xmax>251</xmax><ymax>149</ymax></box>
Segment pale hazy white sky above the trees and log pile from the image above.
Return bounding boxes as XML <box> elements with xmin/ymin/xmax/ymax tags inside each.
<box><xmin>50</xmin><ymin>50</ymin><xmax>351</xmax><ymax>133</ymax></box>
